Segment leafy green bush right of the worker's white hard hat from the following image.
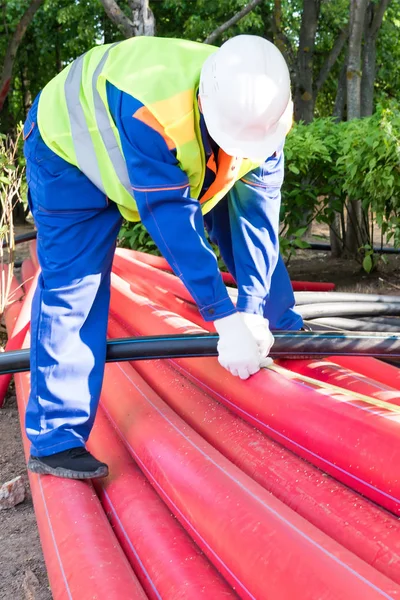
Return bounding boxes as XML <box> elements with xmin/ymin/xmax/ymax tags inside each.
<box><xmin>281</xmin><ymin>104</ymin><xmax>400</xmax><ymax>271</ymax></box>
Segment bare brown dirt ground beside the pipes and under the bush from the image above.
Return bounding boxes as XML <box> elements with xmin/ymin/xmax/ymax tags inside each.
<box><xmin>0</xmin><ymin>221</ymin><xmax>400</xmax><ymax>600</ymax></box>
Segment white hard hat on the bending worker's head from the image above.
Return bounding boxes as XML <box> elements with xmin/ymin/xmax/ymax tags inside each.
<box><xmin>199</xmin><ymin>35</ymin><xmax>293</xmax><ymax>160</ymax></box>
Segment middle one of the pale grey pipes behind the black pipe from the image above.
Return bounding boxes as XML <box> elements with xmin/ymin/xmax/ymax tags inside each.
<box><xmin>297</xmin><ymin>302</ymin><xmax>400</xmax><ymax>320</ymax></box>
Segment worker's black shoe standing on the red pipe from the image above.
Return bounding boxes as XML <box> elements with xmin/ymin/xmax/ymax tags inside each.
<box><xmin>28</xmin><ymin>446</ymin><xmax>108</xmax><ymax>479</ymax></box>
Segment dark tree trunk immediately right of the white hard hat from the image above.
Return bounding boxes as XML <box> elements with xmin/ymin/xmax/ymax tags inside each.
<box><xmin>294</xmin><ymin>0</ymin><xmax>321</xmax><ymax>123</ymax></box>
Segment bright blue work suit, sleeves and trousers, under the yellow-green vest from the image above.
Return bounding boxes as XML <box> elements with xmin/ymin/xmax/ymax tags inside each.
<box><xmin>24</xmin><ymin>84</ymin><xmax>302</xmax><ymax>456</ymax></box>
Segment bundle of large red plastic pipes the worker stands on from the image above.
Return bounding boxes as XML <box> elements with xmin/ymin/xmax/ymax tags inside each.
<box><xmin>2</xmin><ymin>245</ymin><xmax>400</xmax><ymax>600</ymax></box>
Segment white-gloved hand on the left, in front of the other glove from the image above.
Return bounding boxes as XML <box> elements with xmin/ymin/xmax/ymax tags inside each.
<box><xmin>214</xmin><ymin>313</ymin><xmax>260</xmax><ymax>379</ymax></box>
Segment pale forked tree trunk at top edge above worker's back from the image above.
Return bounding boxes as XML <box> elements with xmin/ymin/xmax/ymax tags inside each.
<box><xmin>100</xmin><ymin>0</ymin><xmax>155</xmax><ymax>38</ymax></box>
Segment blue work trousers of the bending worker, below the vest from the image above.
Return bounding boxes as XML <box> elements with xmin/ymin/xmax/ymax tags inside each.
<box><xmin>24</xmin><ymin>100</ymin><xmax>301</xmax><ymax>456</ymax></box>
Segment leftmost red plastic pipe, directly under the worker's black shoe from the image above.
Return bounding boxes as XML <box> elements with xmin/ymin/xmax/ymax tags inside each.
<box><xmin>6</xmin><ymin>296</ymin><xmax>147</xmax><ymax>600</ymax></box>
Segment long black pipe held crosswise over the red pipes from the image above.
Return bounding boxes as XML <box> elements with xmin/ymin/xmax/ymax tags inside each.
<box><xmin>0</xmin><ymin>331</ymin><xmax>400</xmax><ymax>374</ymax></box>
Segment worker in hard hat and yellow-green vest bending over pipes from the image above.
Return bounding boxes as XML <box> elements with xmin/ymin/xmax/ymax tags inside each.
<box><xmin>24</xmin><ymin>35</ymin><xmax>302</xmax><ymax>479</ymax></box>
